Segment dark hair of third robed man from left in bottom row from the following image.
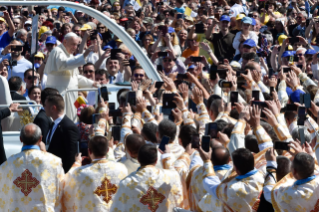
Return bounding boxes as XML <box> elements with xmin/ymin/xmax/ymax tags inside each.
<box><xmin>138</xmin><ymin>144</ymin><xmax>157</xmax><ymax>166</ymax></box>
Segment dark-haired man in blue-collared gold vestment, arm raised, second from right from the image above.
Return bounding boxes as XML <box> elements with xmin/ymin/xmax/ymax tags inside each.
<box><xmin>200</xmin><ymin>148</ymin><xmax>264</xmax><ymax>211</ymax></box>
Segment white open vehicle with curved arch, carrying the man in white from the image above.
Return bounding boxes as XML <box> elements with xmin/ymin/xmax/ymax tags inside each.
<box><xmin>0</xmin><ymin>0</ymin><xmax>162</xmax><ymax>158</ymax></box>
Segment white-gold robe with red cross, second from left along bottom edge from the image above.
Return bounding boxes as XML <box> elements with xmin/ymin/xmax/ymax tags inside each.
<box><xmin>62</xmin><ymin>159</ymin><xmax>127</xmax><ymax>212</ymax></box>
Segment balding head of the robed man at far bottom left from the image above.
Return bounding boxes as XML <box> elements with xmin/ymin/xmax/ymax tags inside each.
<box><xmin>20</xmin><ymin>123</ymin><xmax>42</xmax><ymax>145</ymax></box>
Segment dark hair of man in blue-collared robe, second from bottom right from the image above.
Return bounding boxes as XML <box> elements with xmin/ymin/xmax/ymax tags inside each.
<box><xmin>232</xmin><ymin>148</ymin><xmax>255</xmax><ymax>175</ymax></box>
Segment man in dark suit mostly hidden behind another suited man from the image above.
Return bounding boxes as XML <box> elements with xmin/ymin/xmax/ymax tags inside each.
<box><xmin>33</xmin><ymin>88</ymin><xmax>59</xmax><ymax>144</ymax></box>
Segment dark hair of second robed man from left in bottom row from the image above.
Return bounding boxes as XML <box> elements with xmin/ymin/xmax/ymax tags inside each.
<box><xmin>88</xmin><ymin>136</ymin><xmax>109</xmax><ymax>157</ymax></box>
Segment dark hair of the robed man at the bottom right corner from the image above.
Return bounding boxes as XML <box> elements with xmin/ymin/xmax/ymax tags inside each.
<box><xmin>292</xmin><ymin>152</ymin><xmax>315</xmax><ymax>179</ymax></box>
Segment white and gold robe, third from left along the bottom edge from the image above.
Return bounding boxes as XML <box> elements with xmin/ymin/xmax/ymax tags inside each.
<box><xmin>111</xmin><ymin>165</ymin><xmax>183</xmax><ymax>212</ymax></box>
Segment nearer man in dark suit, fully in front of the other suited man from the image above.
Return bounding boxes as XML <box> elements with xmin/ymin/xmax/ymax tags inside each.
<box><xmin>44</xmin><ymin>94</ymin><xmax>80</xmax><ymax>173</ymax></box>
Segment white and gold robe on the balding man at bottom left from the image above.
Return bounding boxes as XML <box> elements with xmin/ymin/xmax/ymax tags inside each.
<box><xmin>0</xmin><ymin>149</ymin><xmax>64</xmax><ymax>212</ymax></box>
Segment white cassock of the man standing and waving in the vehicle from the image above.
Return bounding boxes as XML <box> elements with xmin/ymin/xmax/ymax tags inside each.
<box><xmin>44</xmin><ymin>44</ymin><xmax>94</xmax><ymax>122</ymax></box>
